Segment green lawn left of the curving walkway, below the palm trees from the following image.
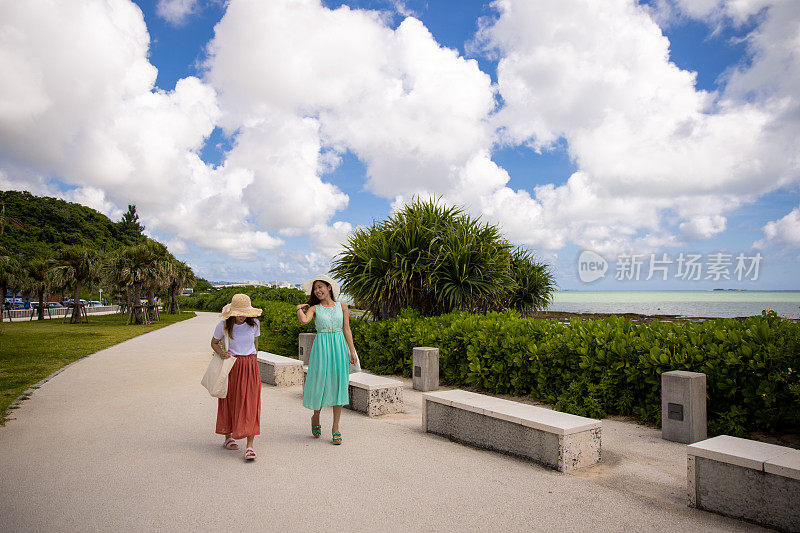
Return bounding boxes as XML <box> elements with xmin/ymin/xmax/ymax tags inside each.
<box><xmin>0</xmin><ymin>312</ymin><xmax>195</xmax><ymax>425</ymax></box>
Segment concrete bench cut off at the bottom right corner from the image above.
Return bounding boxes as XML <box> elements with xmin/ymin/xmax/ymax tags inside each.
<box><xmin>686</xmin><ymin>435</ymin><xmax>800</xmax><ymax>531</ymax></box>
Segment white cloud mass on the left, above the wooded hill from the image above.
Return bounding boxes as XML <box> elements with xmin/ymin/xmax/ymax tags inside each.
<box><xmin>0</xmin><ymin>0</ymin><xmax>290</xmax><ymax>257</ymax></box>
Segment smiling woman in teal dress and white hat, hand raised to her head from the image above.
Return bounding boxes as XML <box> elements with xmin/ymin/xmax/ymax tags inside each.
<box><xmin>297</xmin><ymin>276</ymin><xmax>356</xmax><ymax>444</ymax></box>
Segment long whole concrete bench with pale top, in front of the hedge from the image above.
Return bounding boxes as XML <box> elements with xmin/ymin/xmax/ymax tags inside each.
<box><xmin>422</xmin><ymin>389</ymin><xmax>600</xmax><ymax>472</ymax></box>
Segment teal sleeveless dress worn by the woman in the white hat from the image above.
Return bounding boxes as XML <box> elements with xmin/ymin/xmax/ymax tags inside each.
<box><xmin>303</xmin><ymin>302</ymin><xmax>350</xmax><ymax>411</ymax></box>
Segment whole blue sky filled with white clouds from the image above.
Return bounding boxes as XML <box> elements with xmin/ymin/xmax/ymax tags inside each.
<box><xmin>0</xmin><ymin>0</ymin><xmax>800</xmax><ymax>290</ymax></box>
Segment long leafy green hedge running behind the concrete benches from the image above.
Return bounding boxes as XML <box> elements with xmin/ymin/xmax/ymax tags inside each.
<box><xmin>352</xmin><ymin>312</ymin><xmax>800</xmax><ymax>435</ymax></box>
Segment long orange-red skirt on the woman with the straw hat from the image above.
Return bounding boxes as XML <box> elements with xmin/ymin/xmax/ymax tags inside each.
<box><xmin>217</xmin><ymin>354</ymin><xmax>261</xmax><ymax>439</ymax></box>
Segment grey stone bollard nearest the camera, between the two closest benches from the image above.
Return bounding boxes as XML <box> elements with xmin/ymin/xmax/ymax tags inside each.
<box><xmin>661</xmin><ymin>370</ymin><xmax>708</xmax><ymax>444</ymax></box>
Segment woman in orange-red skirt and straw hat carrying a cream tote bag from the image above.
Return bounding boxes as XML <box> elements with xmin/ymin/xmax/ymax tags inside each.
<box><xmin>211</xmin><ymin>294</ymin><xmax>261</xmax><ymax>461</ymax></box>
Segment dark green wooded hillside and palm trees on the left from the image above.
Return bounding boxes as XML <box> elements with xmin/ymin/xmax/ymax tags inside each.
<box><xmin>0</xmin><ymin>191</ymin><xmax>196</xmax><ymax>324</ymax></box>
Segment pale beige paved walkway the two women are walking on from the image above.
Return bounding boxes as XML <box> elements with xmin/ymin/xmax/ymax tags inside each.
<box><xmin>0</xmin><ymin>313</ymin><xmax>759</xmax><ymax>532</ymax></box>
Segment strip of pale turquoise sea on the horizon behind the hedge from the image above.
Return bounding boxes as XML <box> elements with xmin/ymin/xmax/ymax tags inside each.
<box><xmin>547</xmin><ymin>291</ymin><xmax>800</xmax><ymax>318</ymax></box>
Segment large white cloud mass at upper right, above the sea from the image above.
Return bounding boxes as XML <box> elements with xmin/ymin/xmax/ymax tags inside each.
<box><xmin>462</xmin><ymin>0</ymin><xmax>800</xmax><ymax>254</ymax></box>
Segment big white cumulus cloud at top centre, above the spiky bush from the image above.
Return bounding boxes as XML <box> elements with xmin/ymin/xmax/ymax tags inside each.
<box><xmin>207</xmin><ymin>0</ymin><xmax>494</xmax><ymax>204</ymax></box>
